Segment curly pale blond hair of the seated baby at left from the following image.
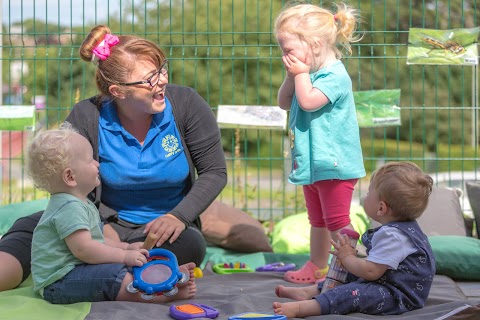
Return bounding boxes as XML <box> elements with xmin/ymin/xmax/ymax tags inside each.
<box><xmin>26</xmin><ymin>122</ymin><xmax>77</xmax><ymax>192</ymax></box>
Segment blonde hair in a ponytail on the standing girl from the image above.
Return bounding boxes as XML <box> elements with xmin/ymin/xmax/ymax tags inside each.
<box><xmin>274</xmin><ymin>1</ymin><xmax>362</xmax><ymax>59</ymax></box>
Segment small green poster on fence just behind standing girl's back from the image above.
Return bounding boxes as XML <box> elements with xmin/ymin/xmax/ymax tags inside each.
<box><xmin>353</xmin><ymin>89</ymin><xmax>401</xmax><ymax>128</ymax></box>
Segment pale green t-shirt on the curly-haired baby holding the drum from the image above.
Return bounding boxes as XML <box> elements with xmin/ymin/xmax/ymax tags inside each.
<box><xmin>32</xmin><ymin>193</ymin><xmax>104</xmax><ymax>296</ymax></box>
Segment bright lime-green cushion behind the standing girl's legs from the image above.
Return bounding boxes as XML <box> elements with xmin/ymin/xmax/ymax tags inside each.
<box><xmin>271</xmin><ymin>206</ymin><xmax>369</xmax><ymax>254</ymax></box>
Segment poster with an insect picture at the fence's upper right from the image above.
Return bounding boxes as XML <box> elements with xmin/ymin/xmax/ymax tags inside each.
<box><xmin>407</xmin><ymin>27</ymin><xmax>480</xmax><ymax>65</ymax></box>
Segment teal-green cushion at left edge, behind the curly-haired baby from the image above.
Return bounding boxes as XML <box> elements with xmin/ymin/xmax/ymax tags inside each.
<box><xmin>0</xmin><ymin>199</ymin><xmax>48</xmax><ymax>235</ymax></box>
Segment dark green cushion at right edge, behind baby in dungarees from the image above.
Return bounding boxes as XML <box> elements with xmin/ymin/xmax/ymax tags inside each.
<box><xmin>428</xmin><ymin>236</ymin><xmax>480</xmax><ymax>280</ymax></box>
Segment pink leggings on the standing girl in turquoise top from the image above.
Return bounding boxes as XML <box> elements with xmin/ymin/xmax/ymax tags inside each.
<box><xmin>303</xmin><ymin>179</ymin><xmax>358</xmax><ymax>231</ymax></box>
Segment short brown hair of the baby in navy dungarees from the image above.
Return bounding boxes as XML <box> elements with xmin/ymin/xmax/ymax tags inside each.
<box><xmin>370</xmin><ymin>162</ymin><xmax>433</xmax><ymax>221</ymax></box>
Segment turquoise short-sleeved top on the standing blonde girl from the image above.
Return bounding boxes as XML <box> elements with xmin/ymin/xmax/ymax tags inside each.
<box><xmin>289</xmin><ymin>60</ymin><xmax>365</xmax><ymax>185</ymax></box>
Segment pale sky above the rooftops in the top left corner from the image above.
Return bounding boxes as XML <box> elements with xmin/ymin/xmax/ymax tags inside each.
<box><xmin>0</xmin><ymin>0</ymin><xmax>122</xmax><ymax>26</ymax></box>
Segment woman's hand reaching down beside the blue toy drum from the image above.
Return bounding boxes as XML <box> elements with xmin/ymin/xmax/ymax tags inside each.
<box><xmin>144</xmin><ymin>213</ymin><xmax>186</xmax><ymax>247</ymax></box>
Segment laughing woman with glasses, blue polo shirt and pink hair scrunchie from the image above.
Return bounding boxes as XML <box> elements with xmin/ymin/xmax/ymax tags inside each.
<box><xmin>0</xmin><ymin>25</ymin><xmax>227</xmax><ymax>290</ymax></box>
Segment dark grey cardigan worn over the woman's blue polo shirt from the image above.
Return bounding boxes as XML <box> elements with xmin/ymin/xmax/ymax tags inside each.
<box><xmin>66</xmin><ymin>84</ymin><xmax>227</xmax><ymax>228</ymax></box>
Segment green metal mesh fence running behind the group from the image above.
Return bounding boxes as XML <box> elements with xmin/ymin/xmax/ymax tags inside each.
<box><xmin>0</xmin><ymin>0</ymin><xmax>479</xmax><ymax>220</ymax></box>
